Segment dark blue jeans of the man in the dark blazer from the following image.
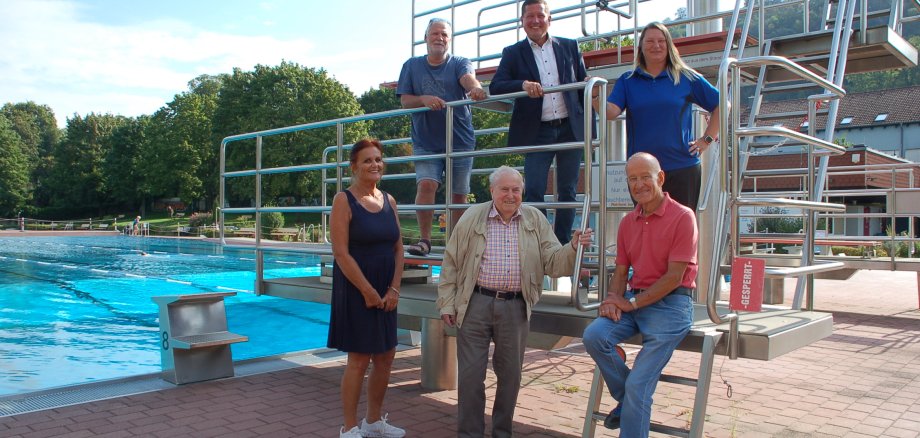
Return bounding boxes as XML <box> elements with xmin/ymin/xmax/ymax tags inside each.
<box><xmin>524</xmin><ymin>120</ymin><xmax>584</xmax><ymax>245</ymax></box>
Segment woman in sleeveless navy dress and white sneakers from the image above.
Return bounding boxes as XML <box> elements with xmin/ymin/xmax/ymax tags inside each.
<box><xmin>328</xmin><ymin>139</ymin><xmax>405</xmax><ymax>437</ymax></box>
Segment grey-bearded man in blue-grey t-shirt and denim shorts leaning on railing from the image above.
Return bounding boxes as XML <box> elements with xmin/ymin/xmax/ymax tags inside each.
<box><xmin>396</xmin><ymin>18</ymin><xmax>487</xmax><ymax>255</ymax></box>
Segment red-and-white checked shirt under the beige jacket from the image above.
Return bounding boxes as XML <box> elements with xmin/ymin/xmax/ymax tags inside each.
<box><xmin>476</xmin><ymin>204</ymin><xmax>521</xmax><ymax>292</ymax></box>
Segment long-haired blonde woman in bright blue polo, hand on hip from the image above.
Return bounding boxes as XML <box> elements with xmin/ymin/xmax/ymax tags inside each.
<box><xmin>607</xmin><ymin>23</ymin><xmax>719</xmax><ymax>211</ymax></box>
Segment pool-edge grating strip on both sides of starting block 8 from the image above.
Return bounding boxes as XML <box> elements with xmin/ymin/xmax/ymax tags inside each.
<box><xmin>0</xmin><ymin>346</ymin><xmax>348</xmax><ymax>418</ymax></box>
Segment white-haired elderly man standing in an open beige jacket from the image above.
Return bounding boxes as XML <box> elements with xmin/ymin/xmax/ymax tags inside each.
<box><xmin>437</xmin><ymin>166</ymin><xmax>592</xmax><ymax>437</ymax></box>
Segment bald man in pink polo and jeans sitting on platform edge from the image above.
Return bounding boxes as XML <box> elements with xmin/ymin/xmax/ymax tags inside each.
<box><xmin>583</xmin><ymin>152</ymin><xmax>697</xmax><ymax>438</ymax></box>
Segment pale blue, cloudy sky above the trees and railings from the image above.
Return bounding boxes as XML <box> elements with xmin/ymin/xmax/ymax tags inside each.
<box><xmin>0</xmin><ymin>0</ymin><xmax>683</xmax><ymax>127</ymax></box>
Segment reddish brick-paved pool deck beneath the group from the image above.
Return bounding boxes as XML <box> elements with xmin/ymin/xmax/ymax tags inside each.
<box><xmin>0</xmin><ymin>271</ymin><xmax>920</xmax><ymax>437</ymax></box>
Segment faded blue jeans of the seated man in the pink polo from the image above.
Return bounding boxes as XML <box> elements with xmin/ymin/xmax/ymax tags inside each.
<box><xmin>583</xmin><ymin>292</ymin><xmax>693</xmax><ymax>438</ymax></box>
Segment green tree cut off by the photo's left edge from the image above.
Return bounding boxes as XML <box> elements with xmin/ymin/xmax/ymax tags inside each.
<box><xmin>0</xmin><ymin>113</ymin><xmax>29</xmax><ymax>217</ymax></box>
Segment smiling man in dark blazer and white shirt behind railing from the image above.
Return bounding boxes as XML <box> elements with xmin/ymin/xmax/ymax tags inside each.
<box><xmin>489</xmin><ymin>0</ymin><xmax>587</xmax><ymax>243</ymax></box>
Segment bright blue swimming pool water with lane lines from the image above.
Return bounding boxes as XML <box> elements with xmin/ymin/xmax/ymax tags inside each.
<box><xmin>0</xmin><ymin>236</ymin><xmax>329</xmax><ymax>396</ymax></box>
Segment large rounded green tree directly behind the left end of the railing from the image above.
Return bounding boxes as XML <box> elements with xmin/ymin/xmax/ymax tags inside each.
<box><xmin>212</xmin><ymin>61</ymin><xmax>369</xmax><ymax>206</ymax></box>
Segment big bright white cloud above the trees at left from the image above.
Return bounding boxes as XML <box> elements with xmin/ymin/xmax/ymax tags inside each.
<box><xmin>0</xmin><ymin>1</ymin><xmax>348</xmax><ymax>125</ymax></box>
